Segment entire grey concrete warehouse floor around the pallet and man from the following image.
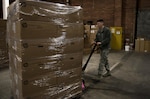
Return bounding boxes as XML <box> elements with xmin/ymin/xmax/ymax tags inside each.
<box><xmin>0</xmin><ymin>51</ymin><xmax>150</xmax><ymax>99</ymax></box>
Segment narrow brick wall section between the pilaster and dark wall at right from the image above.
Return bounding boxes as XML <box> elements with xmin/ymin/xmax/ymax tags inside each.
<box><xmin>122</xmin><ymin>0</ymin><xmax>137</xmax><ymax>42</ymax></box>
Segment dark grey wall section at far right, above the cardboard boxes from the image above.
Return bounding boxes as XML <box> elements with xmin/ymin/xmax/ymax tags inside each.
<box><xmin>137</xmin><ymin>0</ymin><xmax>150</xmax><ymax>39</ymax></box>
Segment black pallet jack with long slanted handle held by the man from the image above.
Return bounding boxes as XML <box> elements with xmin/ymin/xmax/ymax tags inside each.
<box><xmin>82</xmin><ymin>43</ymin><xmax>97</xmax><ymax>90</ymax></box>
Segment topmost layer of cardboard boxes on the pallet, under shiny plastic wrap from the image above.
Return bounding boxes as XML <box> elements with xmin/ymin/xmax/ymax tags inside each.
<box><xmin>9</xmin><ymin>1</ymin><xmax>82</xmax><ymax>24</ymax></box>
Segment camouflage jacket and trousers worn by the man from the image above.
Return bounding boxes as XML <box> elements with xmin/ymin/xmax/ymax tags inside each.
<box><xmin>95</xmin><ymin>27</ymin><xmax>111</xmax><ymax>75</ymax></box>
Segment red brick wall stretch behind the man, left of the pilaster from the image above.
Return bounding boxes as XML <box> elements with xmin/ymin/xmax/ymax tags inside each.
<box><xmin>71</xmin><ymin>0</ymin><xmax>115</xmax><ymax>26</ymax></box>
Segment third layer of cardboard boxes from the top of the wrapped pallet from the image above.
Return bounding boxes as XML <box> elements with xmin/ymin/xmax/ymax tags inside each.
<box><xmin>10</xmin><ymin>38</ymin><xmax>83</xmax><ymax>60</ymax></box>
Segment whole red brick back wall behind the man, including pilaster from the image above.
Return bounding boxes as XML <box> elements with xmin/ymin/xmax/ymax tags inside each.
<box><xmin>71</xmin><ymin>0</ymin><xmax>136</xmax><ymax>41</ymax></box>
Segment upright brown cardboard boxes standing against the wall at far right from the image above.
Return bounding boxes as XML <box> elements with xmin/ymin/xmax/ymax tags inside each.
<box><xmin>135</xmin><ymin>38</ymin><xmax>150</xmax><ymax>52</ymax></box>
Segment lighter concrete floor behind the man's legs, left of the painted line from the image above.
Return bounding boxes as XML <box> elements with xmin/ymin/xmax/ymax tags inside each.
<box><xmin>83</xmin><ymin>51</ymin><xmax>127</xmax><ymax>75</ymax></box>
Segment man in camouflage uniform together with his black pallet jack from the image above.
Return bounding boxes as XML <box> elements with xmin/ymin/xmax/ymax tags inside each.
<box><xmin>82</xmin><ymin>19</ymin><xmax>111</xmax><ymax>90</ymax></box>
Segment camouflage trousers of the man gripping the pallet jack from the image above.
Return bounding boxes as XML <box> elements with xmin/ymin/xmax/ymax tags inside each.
<box><xmin>98</xmin><ymin>49</ymin><xmax>110</xmax><ymax>75</ymax></box>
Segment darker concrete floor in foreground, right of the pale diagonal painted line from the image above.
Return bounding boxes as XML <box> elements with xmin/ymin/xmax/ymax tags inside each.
<box><xmin>82</xmin><ymin>53</ymin><xmax>150</xmax><ymax>99</ymax></box>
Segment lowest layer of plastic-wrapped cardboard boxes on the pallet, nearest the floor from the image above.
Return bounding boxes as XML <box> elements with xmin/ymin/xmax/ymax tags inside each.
<box><xmin>15</xmin><ymin>81</ymin><xmax>82</xmax><ymax>99</ymax></box>
